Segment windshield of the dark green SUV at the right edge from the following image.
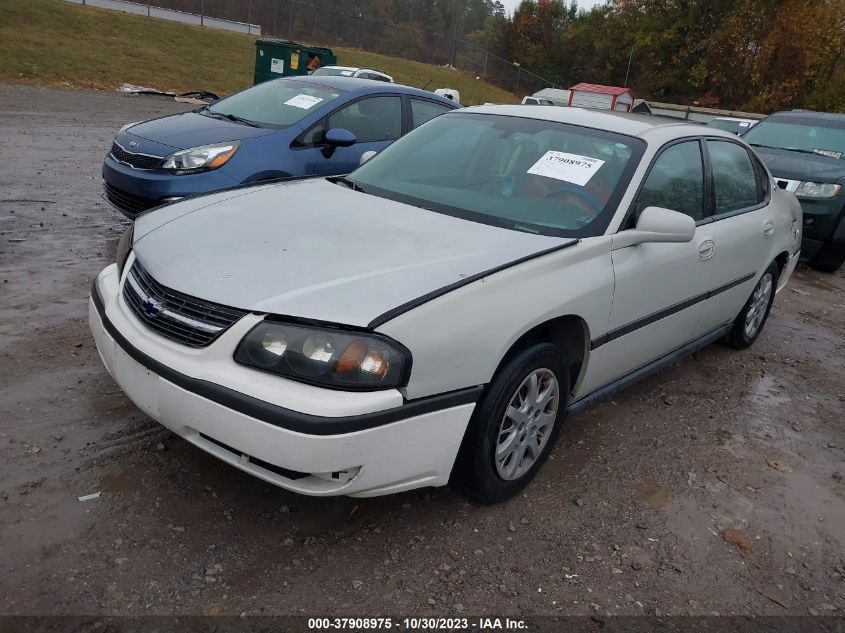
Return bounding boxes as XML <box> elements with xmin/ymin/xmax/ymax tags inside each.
<box><xmin>743</xmin><ymin>118</ymin><xmax>845</xmax><ymax>160</ymax></box>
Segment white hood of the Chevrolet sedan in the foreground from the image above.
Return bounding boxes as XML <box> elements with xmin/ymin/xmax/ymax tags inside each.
<box><xmin>133</xmin><ymin>179</ymin><xmax>572</xmax><ymax>326</ymax></box>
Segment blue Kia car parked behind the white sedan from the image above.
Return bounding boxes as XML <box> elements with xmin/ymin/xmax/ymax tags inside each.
<box><xmin>103</xmin><ymin>77</ymin><xmax>458</xmax><ymax>219</ymax></box>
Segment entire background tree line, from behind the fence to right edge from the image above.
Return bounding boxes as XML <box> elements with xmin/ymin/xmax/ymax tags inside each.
<box><xmin>153</xmin><ymin>0</ymin><xmax>845</xmax><ymax>112</ymax></box>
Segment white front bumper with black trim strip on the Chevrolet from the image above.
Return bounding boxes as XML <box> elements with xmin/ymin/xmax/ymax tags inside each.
<box><xmin>89</xmin><ymin>265</ymin><xmax>480</xmax><ymax>497</ymax></box>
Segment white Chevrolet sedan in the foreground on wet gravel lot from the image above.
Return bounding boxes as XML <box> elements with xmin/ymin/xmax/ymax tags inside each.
<box><xmin>90</xmin><ymin>106</ymin><xmax>802</xmax><ymax>502</ymax></box>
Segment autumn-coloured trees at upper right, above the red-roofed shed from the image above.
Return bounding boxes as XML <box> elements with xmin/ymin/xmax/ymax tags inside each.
<box><xmin>472</xmin><ymin>0</ymin><xmax>845</xmax><ymax>112</ymax></box>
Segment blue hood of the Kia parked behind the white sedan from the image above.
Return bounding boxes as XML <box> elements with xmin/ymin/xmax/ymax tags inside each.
<box><xmin>126</xmin><ymin>112</ymin><xmax>278</xmax><ymax>151</ymax></box>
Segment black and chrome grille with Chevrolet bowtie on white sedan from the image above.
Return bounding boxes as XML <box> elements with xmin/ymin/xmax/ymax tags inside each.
<box><xmin>123</xmin><ymin>259</ymin><xmax>247</xmax><ymax>347</ymax></box>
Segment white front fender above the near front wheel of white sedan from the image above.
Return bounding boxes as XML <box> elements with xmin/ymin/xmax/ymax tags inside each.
<box><xmin>377</xmin><ymin>236</ymin><xmax>614</xmax><ymax>398</ymax></box>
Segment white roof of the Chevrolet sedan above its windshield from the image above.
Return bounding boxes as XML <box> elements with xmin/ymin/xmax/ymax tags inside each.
<box><xmin>454</xmin><ymin>105</ymin><xmax>724</xmax><ymax>138</ymax></box>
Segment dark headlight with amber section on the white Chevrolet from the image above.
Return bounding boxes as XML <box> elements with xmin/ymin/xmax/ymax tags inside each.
<box><xmin>235</xmin><ymin>321</ymin><xmax>411</xmax><ymax>391</ymax></box>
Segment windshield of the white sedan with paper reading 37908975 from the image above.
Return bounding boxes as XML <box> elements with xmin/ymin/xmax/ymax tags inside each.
<box><xmin>349</xmin><ymin>113</ymin><xmax>645</xmax><ymax>237</ymax></box>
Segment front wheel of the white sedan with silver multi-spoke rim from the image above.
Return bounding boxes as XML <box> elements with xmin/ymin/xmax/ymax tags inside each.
<box><xmin>456</xmin><ymin>343</ymin><xmax>569</xmax><ymax>503</ymax></box>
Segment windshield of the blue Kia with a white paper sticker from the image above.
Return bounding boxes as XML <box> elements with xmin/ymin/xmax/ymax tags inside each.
<box><xmin>208</xmin><ymin>79</ymin><xmax>343</xmax><ymax>127</ymax></box>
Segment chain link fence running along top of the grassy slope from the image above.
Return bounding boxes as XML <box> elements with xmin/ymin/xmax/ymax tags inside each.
<box><xmin>142</xmin><ymin>0</ymin><xmax>560</xmax><ymax>96</ymax></box>
